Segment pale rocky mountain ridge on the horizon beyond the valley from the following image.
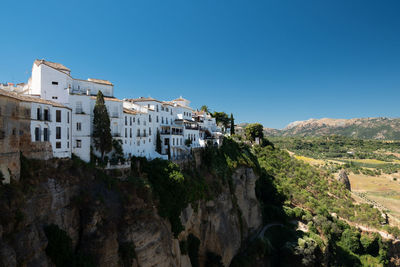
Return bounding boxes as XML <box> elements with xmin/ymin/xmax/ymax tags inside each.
<box><xmin>264</xmin><ymin>118</ymin><xmax>400</xmax><ymax>140</ymax></box>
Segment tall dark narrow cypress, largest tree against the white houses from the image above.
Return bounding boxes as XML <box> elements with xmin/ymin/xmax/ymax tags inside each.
<box><xmin>93</xmin><ymin>91</ymin><xmax>112</xmax><ymax>160</ymax></box>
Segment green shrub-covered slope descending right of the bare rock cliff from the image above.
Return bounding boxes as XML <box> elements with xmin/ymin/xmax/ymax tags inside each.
<box><xmin>232</xmin><ymin>139</ymin><xmax>396</xmax><ymax>266</ymax></box>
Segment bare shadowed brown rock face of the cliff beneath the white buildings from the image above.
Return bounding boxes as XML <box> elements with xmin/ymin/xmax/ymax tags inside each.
<box><xmin>0</xmin><ymin>160</ymin><xmax>262</xmax><ymax>266</ymax></box>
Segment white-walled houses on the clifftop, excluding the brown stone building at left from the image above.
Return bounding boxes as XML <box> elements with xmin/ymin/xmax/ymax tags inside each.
<box><xmin>6</xmin><ymin>60</ymin><xmax>221</xmax><ymax>162</ymax></box>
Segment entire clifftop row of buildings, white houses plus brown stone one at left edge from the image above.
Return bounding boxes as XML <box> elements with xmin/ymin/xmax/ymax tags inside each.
<box><xmin>0</xmin><ymin>60</ymin><xmax>222</xmax><ymax>182</ymax></box>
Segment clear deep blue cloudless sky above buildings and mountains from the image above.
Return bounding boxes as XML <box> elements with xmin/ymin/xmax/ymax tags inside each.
<box><xmin>0</xmin><ymin>0</ymin><xmax>400</xmax><ymax>128</ymax></box>
